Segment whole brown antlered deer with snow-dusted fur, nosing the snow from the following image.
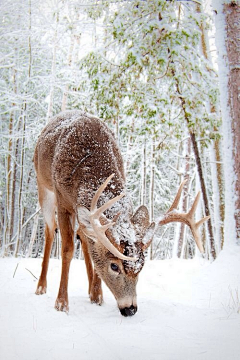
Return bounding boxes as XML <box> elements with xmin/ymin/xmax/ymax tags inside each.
<box><xmin>34</xmin><ymin>110</ymin><xmax>209</xmax><ymax>317</ymax></box>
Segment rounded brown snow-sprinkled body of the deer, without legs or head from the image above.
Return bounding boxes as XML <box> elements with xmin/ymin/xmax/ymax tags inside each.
<box><xmin>34</xmin><ymin>111</ymin><xmax>125</xmax><ymax>212</ymax></box>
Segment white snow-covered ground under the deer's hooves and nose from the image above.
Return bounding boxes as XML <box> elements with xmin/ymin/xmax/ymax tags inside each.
<box><xmin>0</xmin><ymin>247</ymin><xmax>240</xmax><ymax>360</ymax></box>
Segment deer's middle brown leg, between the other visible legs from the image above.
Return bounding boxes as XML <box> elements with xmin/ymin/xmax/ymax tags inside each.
<box><xmin>55</xmin><ymin>209</ymin><xmax>74</xmax><ymax>312</ymax></box>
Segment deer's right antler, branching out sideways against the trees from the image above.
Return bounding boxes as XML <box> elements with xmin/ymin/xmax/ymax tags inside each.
<box><xmin>159</xmin><ymin>180</ymin><xmax>210</xmax><ymax>253</ymax></box>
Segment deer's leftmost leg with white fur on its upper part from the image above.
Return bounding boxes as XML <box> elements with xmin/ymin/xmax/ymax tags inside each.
<box><xmin>36</xmin><ymin>186</ymin><xmax>57</xmax><ymax>295</ymax></box>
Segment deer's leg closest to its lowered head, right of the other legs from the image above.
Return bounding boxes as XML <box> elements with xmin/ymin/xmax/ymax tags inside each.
<box><xmin>77</xmin><ymin>228</ymin><xmax>103</xmax><ymax>305</ymax></box>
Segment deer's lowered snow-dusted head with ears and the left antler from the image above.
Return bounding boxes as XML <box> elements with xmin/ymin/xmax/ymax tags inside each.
<box><xmin>78</xmin><ymin>174</ymin><xmax>155</xmax><ymax>316</ymax></box>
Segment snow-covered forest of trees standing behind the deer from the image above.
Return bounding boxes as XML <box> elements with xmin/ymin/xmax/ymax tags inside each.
<box><xmin>0</xmin><ymin>0</ymin><xmax>240</xmax><ymax>260</ymax></box>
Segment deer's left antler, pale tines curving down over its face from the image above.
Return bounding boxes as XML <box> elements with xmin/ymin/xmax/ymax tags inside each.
<box><xmin>90</xmin><ymin>174</ymin><xmax>137</xmax><ymax>261</ymax></box>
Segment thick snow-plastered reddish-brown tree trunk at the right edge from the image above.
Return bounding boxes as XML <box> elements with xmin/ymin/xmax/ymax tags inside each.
<box><xmin>212</xmin><ymin>0</ymin><xmax>240</xmax><ymax>245</ymax></box>
